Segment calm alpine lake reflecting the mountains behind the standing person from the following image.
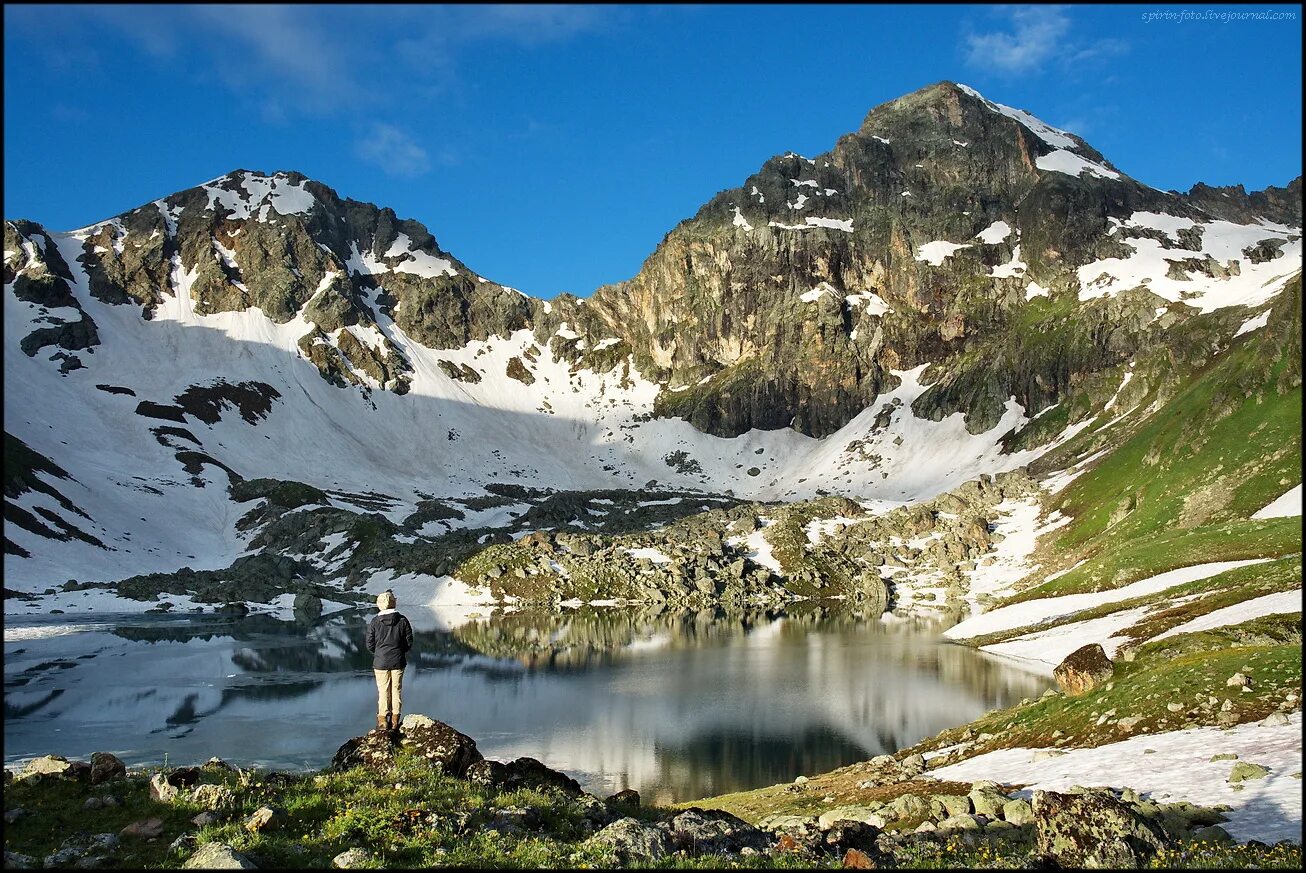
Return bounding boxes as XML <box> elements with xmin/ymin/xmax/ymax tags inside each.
<box><xmin>4</xmin><ymin>608</ymin><xmax>1049</xmax><ymax>802</ymax></box>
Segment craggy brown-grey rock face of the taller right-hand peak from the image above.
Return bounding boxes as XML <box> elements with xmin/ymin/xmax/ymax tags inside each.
<box><xmin>558</xmin><ymin>82</ymin><xmax>1274</xmax><ymax>435</ymax></box>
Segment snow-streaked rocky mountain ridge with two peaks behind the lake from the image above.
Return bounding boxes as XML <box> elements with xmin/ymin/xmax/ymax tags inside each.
<box><xmin>4</xmin><ymin>82</ymin><xmax>1301</xmax><ymax>611</ymax></box>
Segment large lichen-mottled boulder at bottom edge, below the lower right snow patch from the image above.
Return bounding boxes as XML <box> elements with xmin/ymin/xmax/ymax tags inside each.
<box><xmin>1030</xmin><ymin>791</ymin><xmax>1173</xmax><ymax>868</ymax></box>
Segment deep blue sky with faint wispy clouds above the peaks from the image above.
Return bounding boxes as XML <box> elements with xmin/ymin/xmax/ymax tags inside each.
<box><xmin>4</xmin><ymin>5</ymin><xmax>1302</xmax><ymax>297</ymax></box>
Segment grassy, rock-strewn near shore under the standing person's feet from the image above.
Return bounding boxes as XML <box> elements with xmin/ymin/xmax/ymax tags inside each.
<box><xmin>4</xmin><ymin>715</ymin><xmax>1301</xmax><ymax>869</ymax></box>
